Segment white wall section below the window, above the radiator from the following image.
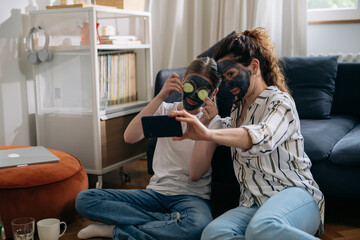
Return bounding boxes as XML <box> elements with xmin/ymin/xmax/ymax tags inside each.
<box><xmin>307</xmin><ymin>23</ymin><xmax>360</xmax><ymax>55</ymax></box>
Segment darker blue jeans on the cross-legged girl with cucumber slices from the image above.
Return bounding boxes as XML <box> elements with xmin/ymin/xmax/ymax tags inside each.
<box><xmin>75</xmin><ymin>189</ymin><xmax>212</xmax><ymax>240</ymax></box>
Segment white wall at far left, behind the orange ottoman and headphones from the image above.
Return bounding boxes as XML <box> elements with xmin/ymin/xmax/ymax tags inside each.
<box><xmin>0</xmin><ymin>0</ymin><xmax>35</xmax><ymax>145</ymax></box>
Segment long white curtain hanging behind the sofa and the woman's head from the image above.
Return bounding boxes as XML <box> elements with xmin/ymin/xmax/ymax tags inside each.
<box><xmin>150</xmin><ymin>0</ymin><xmax>307</xmax><ymax>74</ymax></box>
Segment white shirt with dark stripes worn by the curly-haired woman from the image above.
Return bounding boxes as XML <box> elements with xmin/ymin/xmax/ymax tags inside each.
<box><xmin>223</xmin><ymin>86</ymin><xmax>325</xmax><ymax>233</ymax></box>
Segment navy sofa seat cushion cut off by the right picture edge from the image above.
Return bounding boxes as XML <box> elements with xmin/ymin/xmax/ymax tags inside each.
<box><xmin>329</xmin><ymin>124</ymin><xmax>360</xmax><ymax>166</ymax></box>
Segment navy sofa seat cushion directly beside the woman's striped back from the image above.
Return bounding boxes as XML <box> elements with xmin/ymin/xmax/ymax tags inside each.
<box><xmin>300</xmin><ymin>115</ymin><xmax>357</xmax><ymax>162</ymax></box>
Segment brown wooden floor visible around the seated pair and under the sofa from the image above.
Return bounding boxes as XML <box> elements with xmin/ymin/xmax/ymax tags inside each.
<box><xmin>52</xmin><ymin>160</ymin><xmax>360</xmax><ymax>240</ymax></box>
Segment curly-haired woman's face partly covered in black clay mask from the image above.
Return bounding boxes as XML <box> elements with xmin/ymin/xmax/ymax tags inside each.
<box><xmin>218</xmin><ymin>60</ymin><xmax>251</xmax><ymax>100</ymax></box>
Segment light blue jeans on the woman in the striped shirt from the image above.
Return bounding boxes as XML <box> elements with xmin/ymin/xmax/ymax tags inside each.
<box><xmin>201</xmin><ymin>187</ymin><xmax>321</xmax><ymax>240</ymax></box>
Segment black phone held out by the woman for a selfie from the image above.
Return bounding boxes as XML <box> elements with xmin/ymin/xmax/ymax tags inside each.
<box><xmin>141</xmin><ymin>115</ymin><xmax>182</xmax><ymax>138</ymax></box>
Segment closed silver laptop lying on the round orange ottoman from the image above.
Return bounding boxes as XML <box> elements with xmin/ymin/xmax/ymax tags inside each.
<box><xmin>0</xmin><ymin>146</ymin><xmax>60</xmax><ymax>168</ymax></box>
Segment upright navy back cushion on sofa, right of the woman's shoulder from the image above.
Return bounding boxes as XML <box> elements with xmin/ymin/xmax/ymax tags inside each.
<box><xmin>282</xmin><ymin>56</ymin><xmax>337</xmax><ymax>119</ymax></box>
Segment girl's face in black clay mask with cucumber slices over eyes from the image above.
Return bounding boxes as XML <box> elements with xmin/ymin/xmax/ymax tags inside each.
<box><xmin>183</xmin><ymin>75</ymin><xmax>212</xmax><ymax>111</ymax></box>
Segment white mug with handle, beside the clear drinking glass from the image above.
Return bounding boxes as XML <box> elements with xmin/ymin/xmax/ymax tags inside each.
<box><xmin>37</xmin><ymin>218</ymin><xmax>67</xmax><ymax>240</ymax></box>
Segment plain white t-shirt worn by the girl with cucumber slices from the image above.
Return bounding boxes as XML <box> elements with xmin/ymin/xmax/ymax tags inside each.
<box><xmin>146</xmin><ymin>102</ymin><xmax>222</xmax><ymax>199</ymax></box>
